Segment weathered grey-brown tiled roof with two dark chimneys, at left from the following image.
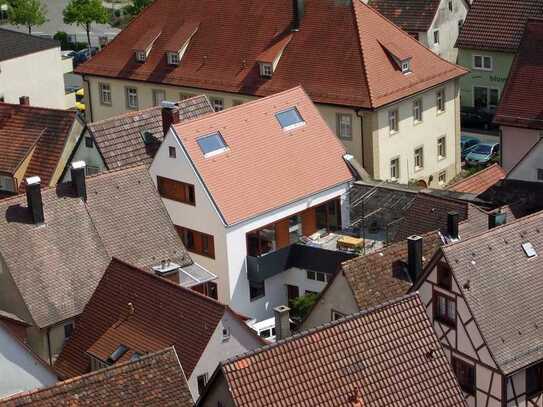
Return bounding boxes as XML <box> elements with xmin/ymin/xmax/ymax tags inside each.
<box><xmin>0</xmin><ymin>166</ymin><xmax>192</xmax><ymax>328</ymax></box>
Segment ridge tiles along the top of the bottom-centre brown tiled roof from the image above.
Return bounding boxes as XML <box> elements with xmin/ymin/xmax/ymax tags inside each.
<box><xmin>220</xmin><ymin>292</ymin><xmax>420</xmax><ymax>367</ymax></box>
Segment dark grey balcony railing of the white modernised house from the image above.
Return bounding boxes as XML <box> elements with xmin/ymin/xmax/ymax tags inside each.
<box><xmin>247</xmin><ymin>243</ymin><xmax>356</xmax><ymax>282</ymax></box>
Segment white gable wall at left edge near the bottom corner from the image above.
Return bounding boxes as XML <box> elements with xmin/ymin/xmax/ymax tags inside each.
<box><xmin>0</xmin><ymin>325</ymin><xmax>57</xmax><ymax>398</ymax></box>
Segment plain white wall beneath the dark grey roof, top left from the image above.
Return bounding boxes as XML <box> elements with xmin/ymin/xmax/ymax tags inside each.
<box><xmin>0</xmin><ymin>48</ymin><xmax>68</xmax><ymax>109</ymax></box>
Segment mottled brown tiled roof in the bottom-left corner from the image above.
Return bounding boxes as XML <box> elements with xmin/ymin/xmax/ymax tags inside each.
<box><xmin>0</xmin><ymin>347</ymin><xmax>193</xmax><ymax>407</ymax></box>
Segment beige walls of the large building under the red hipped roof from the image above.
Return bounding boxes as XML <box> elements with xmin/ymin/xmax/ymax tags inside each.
<box><xmin>85</xmin><ymin>76</ymin><xmax>460</xmax><ymax>187</ymax></box>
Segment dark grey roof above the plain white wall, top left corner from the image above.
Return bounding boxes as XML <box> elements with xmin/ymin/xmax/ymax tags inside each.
<box><xmin>0</xmin><ymin>28</ymin><xmax>60</xmax><ymax>61</ymax></box>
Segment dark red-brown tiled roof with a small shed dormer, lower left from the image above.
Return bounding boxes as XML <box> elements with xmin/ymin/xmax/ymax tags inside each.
<box><xmin>55</xmin><ymin>259</ymin><xmax>257</xmax><ymax>377</ymax></box>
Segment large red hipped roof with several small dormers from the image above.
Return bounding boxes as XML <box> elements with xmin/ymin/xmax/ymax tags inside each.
<box><xmin>77</xmin><ymin>0</ymin><xmax>467</xmax><ymax>109</ymax></box>
